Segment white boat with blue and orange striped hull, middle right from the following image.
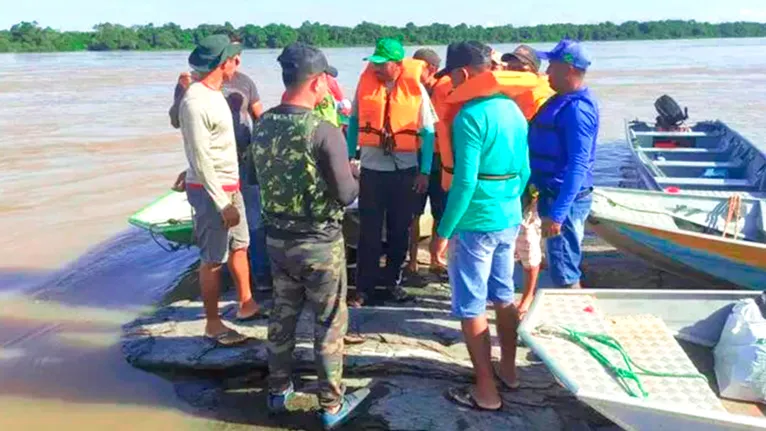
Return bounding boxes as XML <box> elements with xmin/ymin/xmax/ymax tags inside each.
<box><xmin>588</xmin><ymin>187</ymin><xmax>766</xmax><ymax>290</ymax></box>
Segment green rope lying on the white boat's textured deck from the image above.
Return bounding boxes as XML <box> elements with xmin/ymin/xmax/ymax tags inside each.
<box><xmin>548</xmin><ymin>327</ymin><xmax>707</xmax><ymax>398</ymax></box>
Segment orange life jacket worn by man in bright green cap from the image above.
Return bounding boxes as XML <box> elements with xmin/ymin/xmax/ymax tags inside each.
<box><xmin>356</xmin><ymin>59</ymin><xmax>426</xmax><ymax>152</ymax></box>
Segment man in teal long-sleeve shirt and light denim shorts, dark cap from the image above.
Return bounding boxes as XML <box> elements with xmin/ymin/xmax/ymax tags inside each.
<box><xmin>437</xmin><ymin>42</ymin><xmax>530</xmax><ymax>416</ymax></box>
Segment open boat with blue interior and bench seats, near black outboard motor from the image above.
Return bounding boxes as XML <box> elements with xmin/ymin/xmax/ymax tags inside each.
<box><xmin>625</xmin><ymin>120</ymin><xmax>766</xmax><ymax>197</ymax></box>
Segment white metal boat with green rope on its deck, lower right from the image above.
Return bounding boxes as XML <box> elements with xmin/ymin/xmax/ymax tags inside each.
<box><xmin>519</xmin><ymin>289</ymin><xmax>766</xmax><ymax>431</ymax></box>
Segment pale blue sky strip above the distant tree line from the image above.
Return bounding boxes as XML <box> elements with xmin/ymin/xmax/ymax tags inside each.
<box><xmin>0</xmin><ymin>0</ymin><xmax>766</xmax><ymax>30</ymax></box>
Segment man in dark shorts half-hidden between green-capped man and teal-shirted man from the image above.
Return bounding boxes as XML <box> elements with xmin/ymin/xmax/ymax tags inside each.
<box><xmin>407</xmin><ymin>48</ymin><xmax>452</xmax><ymax>274</ymax></box>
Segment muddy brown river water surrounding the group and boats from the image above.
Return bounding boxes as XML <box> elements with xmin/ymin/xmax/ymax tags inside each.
<box><xmin>0</xmin><ymin>39</ymin><xmax>766</xmax><ymax>429</ymax></box>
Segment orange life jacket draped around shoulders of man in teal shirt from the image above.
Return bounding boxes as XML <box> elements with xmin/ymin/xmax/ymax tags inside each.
<box><xmin>437</xmin><ymin>71</ymin><xmax>550</xmax><ymax>190</ymax></box>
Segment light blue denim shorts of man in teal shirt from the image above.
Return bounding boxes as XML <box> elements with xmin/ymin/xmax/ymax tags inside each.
<box><xmin>447</xmin><ymin>225</ymin><xmax>520</xmax><ymax>319</ymax></box>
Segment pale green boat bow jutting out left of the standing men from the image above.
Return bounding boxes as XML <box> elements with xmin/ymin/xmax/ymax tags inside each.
<box><xmin>128</xmin><ymin>191</ymin><xmax>194</xmax><ymax>248</ymax></box>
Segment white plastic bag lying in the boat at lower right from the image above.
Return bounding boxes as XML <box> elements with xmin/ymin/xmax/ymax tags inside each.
<box><xmin>714</xmin><ymin>299</ymin><xmax>766</xmax><ymax>403</ymax></box>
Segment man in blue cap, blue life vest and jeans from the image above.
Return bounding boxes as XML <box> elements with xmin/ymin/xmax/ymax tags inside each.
<box><xmin>529</xmin><ymin>39</ymin><xmax>599</xmax><ymax>289</ymax></box>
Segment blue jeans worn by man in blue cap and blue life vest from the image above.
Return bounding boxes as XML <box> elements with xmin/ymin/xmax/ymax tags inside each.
<box><xmin>538</xmin><ymin>194</ymin><xmax>593</xmax><ymax>287</ymax></box>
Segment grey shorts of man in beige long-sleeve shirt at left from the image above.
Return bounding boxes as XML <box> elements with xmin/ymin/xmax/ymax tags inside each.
<box><xmin>186</xmin><ymin>187</ymin><xmax>250</xmax><ymax>264</ymax></box>
